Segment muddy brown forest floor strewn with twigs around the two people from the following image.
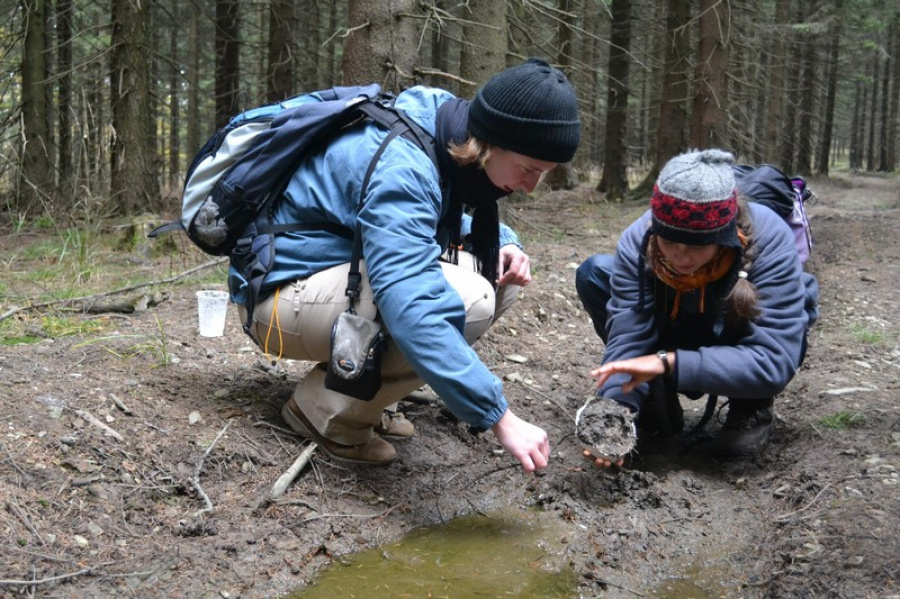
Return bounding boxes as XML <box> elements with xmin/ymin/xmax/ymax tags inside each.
<box><xmin>0</xmin><ymin>173</ymin><xmax>900</xmax><ymax>599</ymax></box>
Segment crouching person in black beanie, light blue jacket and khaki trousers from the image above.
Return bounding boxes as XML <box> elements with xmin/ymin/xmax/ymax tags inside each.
<box><xmin>229</xmin><ymin>58</ymin><xmax>580</xmax><ymax>472</ymax></box>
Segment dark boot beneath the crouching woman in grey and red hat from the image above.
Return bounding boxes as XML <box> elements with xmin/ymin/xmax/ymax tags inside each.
<box><xmin>708</xmin><ymin>398</ymin><xmax>775</xmax><ymax>456</ymax></box>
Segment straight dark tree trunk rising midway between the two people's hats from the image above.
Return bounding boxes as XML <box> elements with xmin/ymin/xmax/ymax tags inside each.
<box><xmin>597</xmin><ymin>0</ymin><xmax>631</xmax><ymax>200</ymax></box>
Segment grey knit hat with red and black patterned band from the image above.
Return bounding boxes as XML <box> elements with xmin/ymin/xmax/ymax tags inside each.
<box><xmin>650</xmin><ymin>149</ymin><xmax>740</xmax><ymax>247</ymax></box>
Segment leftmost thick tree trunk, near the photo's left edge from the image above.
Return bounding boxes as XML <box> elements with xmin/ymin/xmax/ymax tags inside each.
<box><xmin>16</xmin><ymin>0</ymin><xmax>53</xmax><ymax>212</ymax></box>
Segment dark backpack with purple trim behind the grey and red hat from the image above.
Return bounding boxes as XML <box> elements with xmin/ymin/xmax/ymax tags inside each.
<box><xmin>732</xmin><ymin>164</ymin><xmax>815</xmax><ymax>264</ymax></box>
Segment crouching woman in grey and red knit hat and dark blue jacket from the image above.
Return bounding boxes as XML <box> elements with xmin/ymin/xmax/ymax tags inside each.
<box><xmin>575</xmin><ymin>149</ymin><xmax>818</xmax><ymax>467</ymax></box>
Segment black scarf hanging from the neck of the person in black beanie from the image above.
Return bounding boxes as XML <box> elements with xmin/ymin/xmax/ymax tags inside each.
<box><xmin>435</xmin><ymin>98</ymin><xmax>506</xmax><ymax>286</ymax></box>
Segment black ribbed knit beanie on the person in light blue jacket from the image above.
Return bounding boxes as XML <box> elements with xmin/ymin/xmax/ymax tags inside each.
<box><xmin>469</xmin><ymin>58</ymin><xmax>581</xmax><ymax>162</ymax></box>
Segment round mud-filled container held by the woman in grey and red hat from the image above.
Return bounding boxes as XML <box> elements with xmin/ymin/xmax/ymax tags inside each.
<box><xmin>575</xmin><ymin>397</ymin><xmax>637</xmax><ymax>459</ymax></box>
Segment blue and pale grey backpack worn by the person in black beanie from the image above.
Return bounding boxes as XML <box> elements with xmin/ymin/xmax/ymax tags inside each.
<box><xmin>149</xmin><ymin>84</ymin><xmax>443</xmax><ymax>332</ymax></box>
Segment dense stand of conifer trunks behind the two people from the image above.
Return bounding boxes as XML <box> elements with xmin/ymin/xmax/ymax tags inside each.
<box><xmin>0</xmin><ymin>0</ymin><xmax>900</xmax><ymax>231</ymax></box>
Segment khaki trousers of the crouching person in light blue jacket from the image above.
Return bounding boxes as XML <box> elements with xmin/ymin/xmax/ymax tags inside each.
<box><xmin>242</xmin><ymin>252</ymin><xmax>521</xmax><ymax>445</ymax></box>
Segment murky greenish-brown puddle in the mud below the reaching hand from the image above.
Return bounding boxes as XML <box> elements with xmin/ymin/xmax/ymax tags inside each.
<box><xmin>288</xmin><ymin>511</ymin><xmax>578</xmax><ymax>599</ymax></box>
